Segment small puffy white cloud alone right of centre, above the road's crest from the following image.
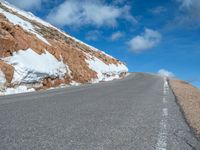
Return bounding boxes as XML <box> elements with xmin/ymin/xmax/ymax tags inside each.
<box><xmin>128</xmin><ymin>28</ymin><xmax>162</xmax><ymax>52</ymax></box>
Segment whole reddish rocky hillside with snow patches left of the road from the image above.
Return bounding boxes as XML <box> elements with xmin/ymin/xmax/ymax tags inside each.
<box><xmin>0</xmin><ymin>2</ymin><xmax>128</xmax><ymax>93</ymax></box>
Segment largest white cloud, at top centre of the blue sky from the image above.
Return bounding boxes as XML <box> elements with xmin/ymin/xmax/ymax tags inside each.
<box><xmin>47</xmin><ymin>0</ymin><xmax>136</xmax><ymax>27</ymax></box>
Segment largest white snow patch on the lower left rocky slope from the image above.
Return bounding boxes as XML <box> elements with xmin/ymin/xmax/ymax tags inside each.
<box><xmin>3</xmin><ymin>48</ymin><xmax>70</xmax><ymax>84</ymax></box>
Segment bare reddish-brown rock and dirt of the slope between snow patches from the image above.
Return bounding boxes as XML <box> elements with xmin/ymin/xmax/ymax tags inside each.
<box><xmin>0</xmin><ymin>2</ymin><xmax>128</xmax><ymax>91</ymax></box>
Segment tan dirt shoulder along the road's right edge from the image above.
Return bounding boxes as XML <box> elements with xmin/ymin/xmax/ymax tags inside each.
<box><xmin>169</xmin><ymin>79</ymin><xmax>200</xmax><ymax>137</ymax></box>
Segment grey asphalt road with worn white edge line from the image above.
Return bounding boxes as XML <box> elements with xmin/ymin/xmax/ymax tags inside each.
<box><xmin>0</xmin><ymin>73</ymin><xmax>200</xmax><ymax>150</ymax></box>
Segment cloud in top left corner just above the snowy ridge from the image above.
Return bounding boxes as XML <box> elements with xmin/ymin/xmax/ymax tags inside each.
<box><xmin>7</xmin><ymin>0</ymin><xmax>44</xmax><ymax>10</ymax></box>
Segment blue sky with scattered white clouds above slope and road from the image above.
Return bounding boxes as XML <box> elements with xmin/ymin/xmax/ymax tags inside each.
<box><xmin>5</xmin><ymin>0</ymin><xmax>200</xmax><ymax>87</ymax></box>
